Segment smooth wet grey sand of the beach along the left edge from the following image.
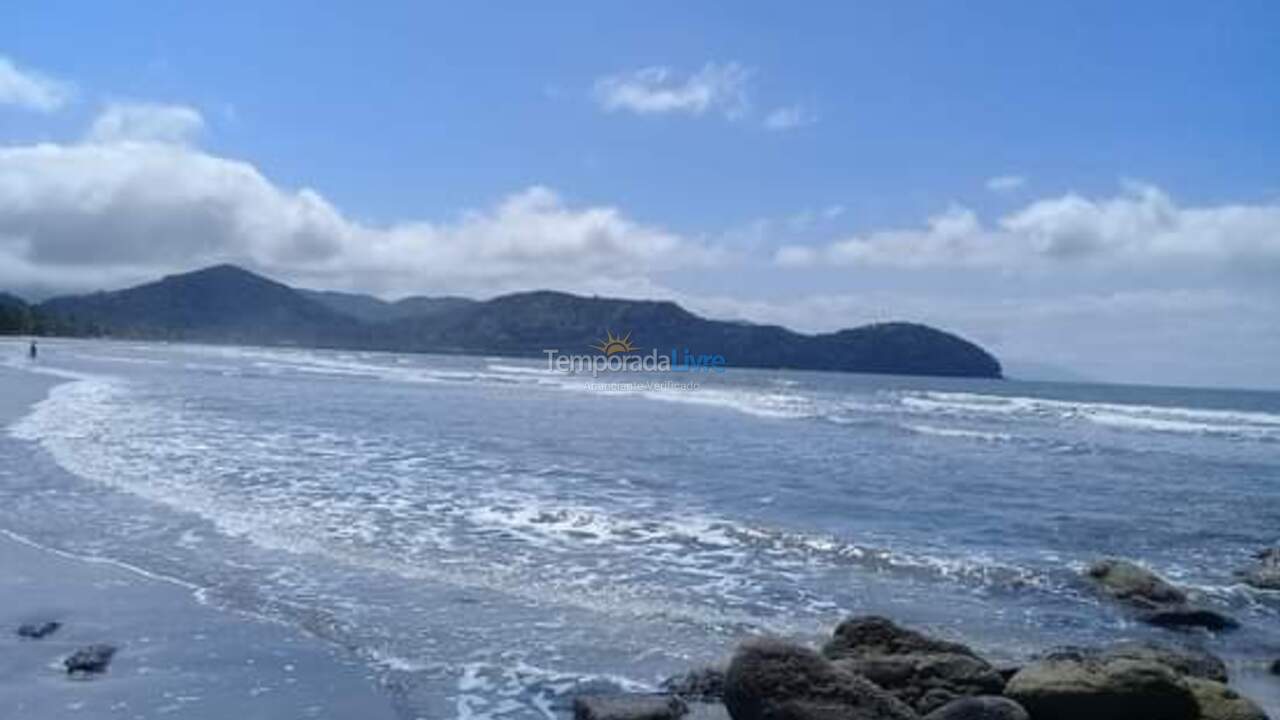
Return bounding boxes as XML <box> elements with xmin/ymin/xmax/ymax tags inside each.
<box><xmin>0</xmin><ymin>366</ymin><xmax>397</xmax><ymax>720</ymax></box>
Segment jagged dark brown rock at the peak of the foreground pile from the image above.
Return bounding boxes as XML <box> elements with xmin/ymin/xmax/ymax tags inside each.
<box><xmin>823</xmin><ymin>616</ymin><xmax>1005</xmax><ymax>715</ymax></box>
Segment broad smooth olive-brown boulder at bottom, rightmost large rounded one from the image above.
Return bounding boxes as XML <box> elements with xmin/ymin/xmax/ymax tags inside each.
<box><xmin>1005</xmin><ymin>659</ymin><xmax>1199</xmax><ymax>720</ymax></box>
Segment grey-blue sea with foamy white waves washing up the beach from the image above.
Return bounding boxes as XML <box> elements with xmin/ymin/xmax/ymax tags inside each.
<box><xmin>0</xmin><ymin>342</ymin><xmax>1280</xmax><ymax>717</ymax></box>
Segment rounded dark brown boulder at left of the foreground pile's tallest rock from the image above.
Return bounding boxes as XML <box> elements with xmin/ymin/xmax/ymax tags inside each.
<box><xmin>724</xmin><ymin>639</ymin><xmax>916</xmax><ymax>720</ymax></box>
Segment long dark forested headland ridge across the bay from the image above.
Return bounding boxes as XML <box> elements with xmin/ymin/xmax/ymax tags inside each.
<box><xmin>36</xmin><ymin>265</ymin><xmax>1001</xmax><ymax>378</ymax></box>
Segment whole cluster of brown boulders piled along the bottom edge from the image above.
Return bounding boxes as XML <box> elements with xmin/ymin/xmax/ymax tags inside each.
<box><xmin>575</xmin><ymin>609</ymin><xmax>1266</xmax><ymax>720</ymax></box>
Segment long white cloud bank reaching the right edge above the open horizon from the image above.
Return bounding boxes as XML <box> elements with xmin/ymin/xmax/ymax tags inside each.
<box><xmin>774</xmin><ymin>183</ymin><xmax>1280</xmax><ymax>268</ymax></box>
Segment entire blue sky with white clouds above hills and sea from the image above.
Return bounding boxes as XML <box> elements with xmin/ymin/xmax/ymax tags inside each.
<box><xmin>0</xmin><ymin>0</ymin><xmax>1280</xmax><ymax>388</ymax></box>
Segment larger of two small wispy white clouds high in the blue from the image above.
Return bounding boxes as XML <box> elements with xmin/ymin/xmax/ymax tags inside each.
<box><xmin>594</xmin><ymin>63</ymin><xmax>751</xmax><ymax>119</ymax></box>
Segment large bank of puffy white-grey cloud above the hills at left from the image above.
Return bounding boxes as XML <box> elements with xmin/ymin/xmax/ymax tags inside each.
<box><xmin>0</xmin><ymin>133</ymin><xmax>718</xmax><ymax>293</ymax></box>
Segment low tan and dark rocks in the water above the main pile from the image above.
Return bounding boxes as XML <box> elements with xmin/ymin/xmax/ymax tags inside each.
<box><xmin>1085</xmin><ymin>559</ymin><xmax>1239</xmax><ymax>630</ymax></box>
